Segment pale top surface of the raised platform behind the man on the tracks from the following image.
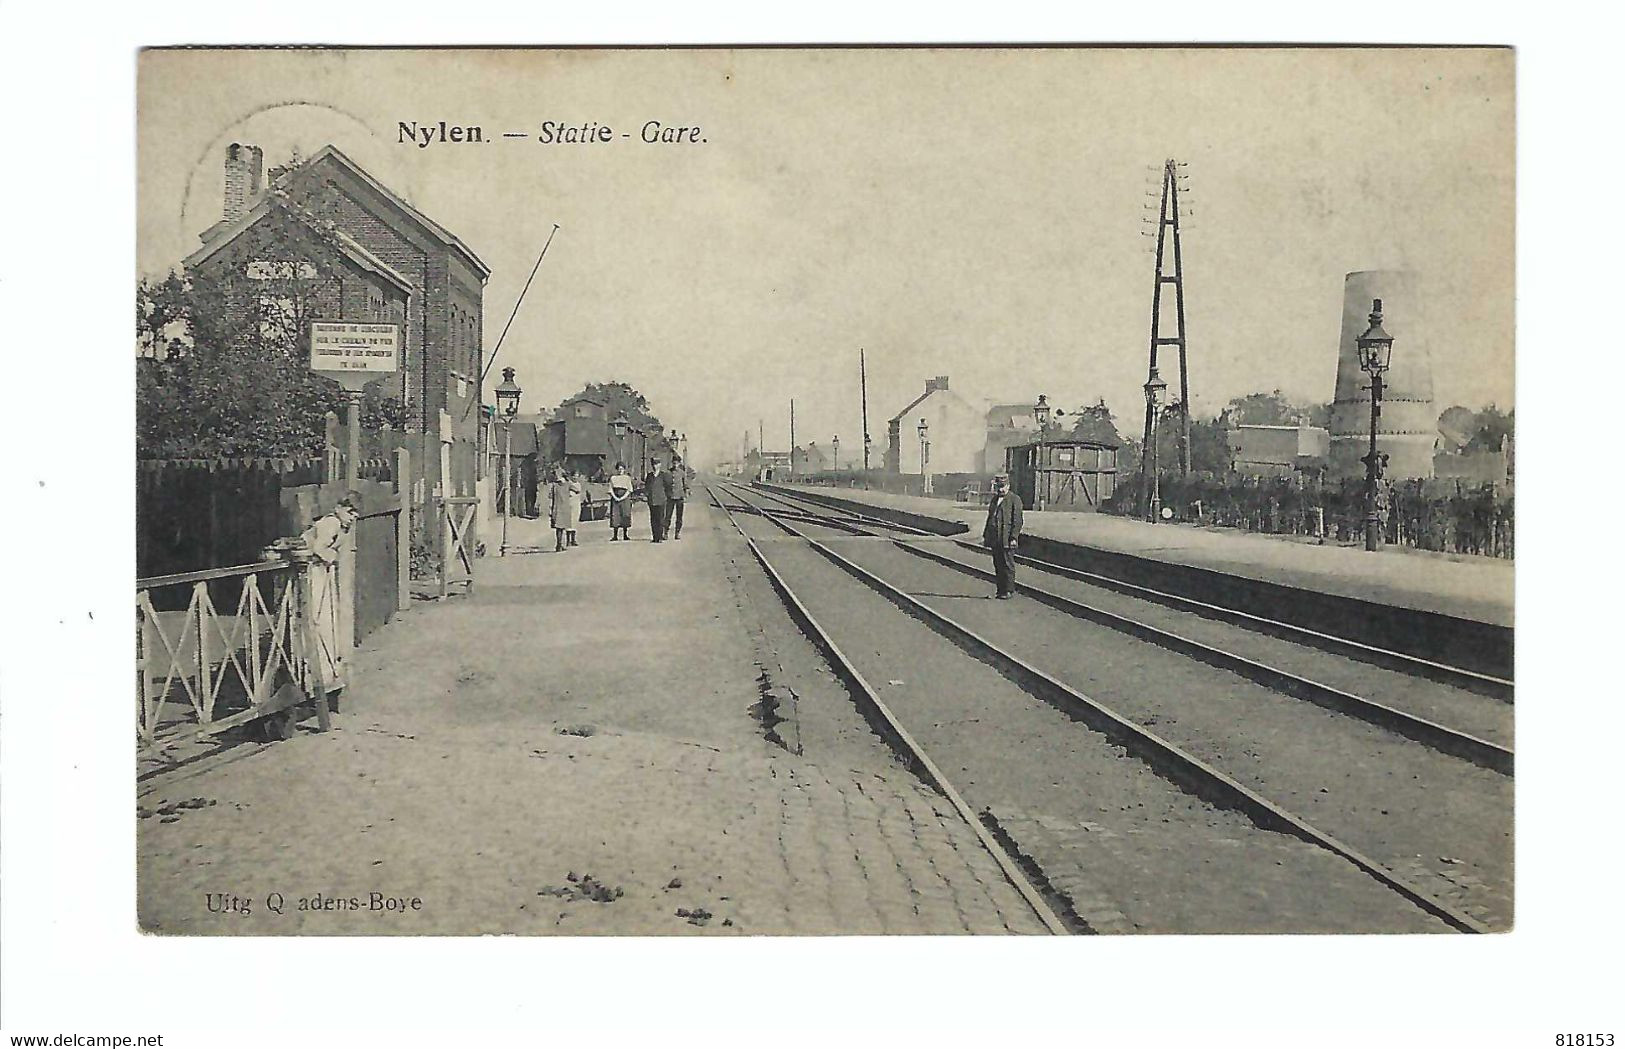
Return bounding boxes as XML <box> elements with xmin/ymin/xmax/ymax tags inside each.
<box><xmin>774</xmin><ymin>482</ymin><xmax>1513</xmax><ymax>627</ymax></box>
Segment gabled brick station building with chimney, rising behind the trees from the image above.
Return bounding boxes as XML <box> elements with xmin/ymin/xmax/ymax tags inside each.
<box><xmin>185</xmin><ymin>143</ymin><xmax>491</xmax><ymax>448</ymax></box>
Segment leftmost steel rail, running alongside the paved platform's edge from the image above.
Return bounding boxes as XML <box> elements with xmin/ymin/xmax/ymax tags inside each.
<box><xmin>705</xmin><ymin>484</ymin><xmax>1071</xmax><ymax>935</ymax></box>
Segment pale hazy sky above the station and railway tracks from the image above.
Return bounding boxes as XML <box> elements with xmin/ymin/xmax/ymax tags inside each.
<box><xmin>138</xmin><ymin>49</ymin><xmax>1515</xmax><ymax>463</ymax></box>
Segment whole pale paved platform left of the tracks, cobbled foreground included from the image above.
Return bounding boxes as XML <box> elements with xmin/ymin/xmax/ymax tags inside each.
<box><xmin>138</xmin><ymin>500</ymin><xmax>1043</xmax><ymax>935</ymax></box>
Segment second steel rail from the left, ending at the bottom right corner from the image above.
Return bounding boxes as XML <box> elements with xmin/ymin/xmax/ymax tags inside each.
<box><xmin>724</xmin><ymin>483</ymin><xmax>1489</xmax><ymax>932</ymax></box>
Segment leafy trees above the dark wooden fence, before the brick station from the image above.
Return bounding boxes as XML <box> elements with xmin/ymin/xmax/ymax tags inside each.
<box><xmin>135</xmin><ymin>192</ymin><xmax>403</xmax><ymax>458</ymax></box>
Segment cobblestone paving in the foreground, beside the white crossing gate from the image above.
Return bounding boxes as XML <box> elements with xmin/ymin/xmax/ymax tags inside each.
<box><xmin>140</xmin><ymin>716</ymin><xmax>1043</xmax><ymax>935</ymax></box>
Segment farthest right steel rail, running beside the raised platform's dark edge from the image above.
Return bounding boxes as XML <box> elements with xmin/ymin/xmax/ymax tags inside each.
<box><xmin>764</xmin><ymin>489</ymin><xmax>1513</xmax><ymax>703</ymax></box>
